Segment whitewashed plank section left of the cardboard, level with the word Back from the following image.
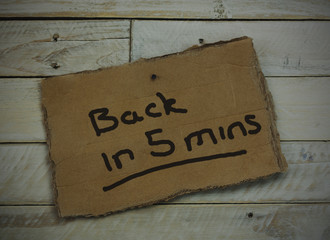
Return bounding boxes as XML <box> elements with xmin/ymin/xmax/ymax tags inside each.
<box><xmin>0</xmin><ymin>78</ymin><xmax>46</xmax><ymax>142</ymax></box>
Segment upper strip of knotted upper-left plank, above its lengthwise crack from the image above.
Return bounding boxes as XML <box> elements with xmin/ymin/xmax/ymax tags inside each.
<box><xmin>0</xmin><ymin>20</ymin><xmax>130</xmax><ymax>42</ymax></box>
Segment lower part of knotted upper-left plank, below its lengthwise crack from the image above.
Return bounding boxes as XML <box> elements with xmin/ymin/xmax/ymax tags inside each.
<box><xmin>0</xmin><ymin>39</ymin><xmax>129</xmax><ymax>76</ymax></box>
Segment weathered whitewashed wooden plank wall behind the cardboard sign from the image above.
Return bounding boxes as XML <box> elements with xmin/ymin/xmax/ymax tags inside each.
<box><xmin>0</xmin><ymin>0</ymin><xmax>330</xmax><ymax>239</ymax></box>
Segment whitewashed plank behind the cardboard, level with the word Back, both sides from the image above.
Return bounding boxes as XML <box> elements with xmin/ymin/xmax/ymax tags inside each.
<box><xmin>0</xmin><ymin>77</ymin><xmax>330</xmax><ymax>142</ymax></box>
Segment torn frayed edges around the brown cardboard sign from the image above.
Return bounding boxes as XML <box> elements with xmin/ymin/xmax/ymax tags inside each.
<box><xmin>42</xmin><ymin>36</ymin><xmax>288</xmax><ymax>217</ymax></box>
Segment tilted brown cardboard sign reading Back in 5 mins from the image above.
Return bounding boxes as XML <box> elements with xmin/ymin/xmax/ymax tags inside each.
<box><xmin>42</xmin><ymin>37</ymin><xmax>287</xmax><ymax>216</ymax></box>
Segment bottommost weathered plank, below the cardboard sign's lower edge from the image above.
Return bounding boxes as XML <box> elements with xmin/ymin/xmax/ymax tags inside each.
<box><xmin>0</xmin><ymin>204</ymin><xmax>330</xmax><ymax>240</ymax></box>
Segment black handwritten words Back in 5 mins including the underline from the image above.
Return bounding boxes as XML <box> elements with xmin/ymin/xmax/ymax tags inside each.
<box><xmin>88</xmin><ymin>89</ymin><xmax>261</xmax><ymax>192</ymax></box>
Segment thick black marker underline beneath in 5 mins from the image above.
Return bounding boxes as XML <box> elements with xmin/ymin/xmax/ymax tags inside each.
<box><xmin>103</xmin><ymin>150</ymin><xmax>247</xmax><ymax>192</ymax></box>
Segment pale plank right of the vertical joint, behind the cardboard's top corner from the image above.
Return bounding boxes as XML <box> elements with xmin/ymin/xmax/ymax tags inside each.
<box><xmin>131</xmin><ymin>21</ymin><xmax>330</xmax><ymax>76</ymax></box>
